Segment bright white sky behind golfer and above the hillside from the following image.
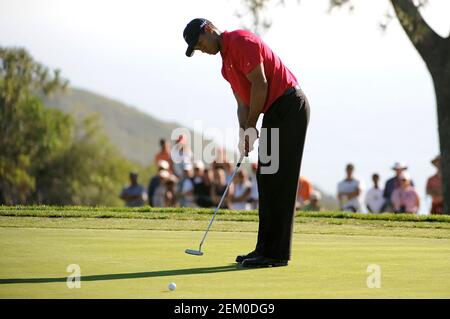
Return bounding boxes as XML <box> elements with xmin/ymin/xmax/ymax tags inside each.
<box><xmin>0</xmin><ymin>0</ymin><xmax>450</xmax><ymax>212</ymax></box>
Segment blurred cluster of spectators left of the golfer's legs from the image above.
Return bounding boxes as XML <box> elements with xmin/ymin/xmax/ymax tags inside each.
<box><xmin>121</xmin><ymin>136</ymin><xmax>258</xmax><ymax>210</ymax></box>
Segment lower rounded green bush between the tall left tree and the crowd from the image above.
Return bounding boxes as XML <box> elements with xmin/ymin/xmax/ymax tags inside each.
<box><xmin>34</xmin><ymin>115</ymin><xmax>135</xmax><ymax>206</ymax></box>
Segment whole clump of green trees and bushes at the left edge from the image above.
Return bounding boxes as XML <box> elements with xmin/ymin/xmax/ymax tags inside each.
<box><xmin>0</xmin><ymin>47</ymin><xmax>139</xmax><ymax>206</ymax></box>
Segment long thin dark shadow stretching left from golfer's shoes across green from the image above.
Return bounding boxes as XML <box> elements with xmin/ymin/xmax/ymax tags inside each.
<box><xmin>0</xmin><ymin>264</ymin><xmax>248</xmax><ymax>285</ymax></box>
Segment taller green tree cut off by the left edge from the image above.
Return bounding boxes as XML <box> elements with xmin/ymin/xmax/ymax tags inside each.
<box><xmin>0</xmin><ymin>47</ymin><xmax>70</xmax><ymax>204</ymax></box>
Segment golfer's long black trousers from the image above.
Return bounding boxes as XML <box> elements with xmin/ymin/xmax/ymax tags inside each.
<box><xmin>256</xmin><ymin>90</ymin><xmax>309</xmax><ymax>260</ymax></box>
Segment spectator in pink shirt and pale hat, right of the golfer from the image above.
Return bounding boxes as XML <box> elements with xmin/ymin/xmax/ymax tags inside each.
<box><xmin>391</xmin><ymin>172</ymin><xmax>420</xmax><ymax>214</ymax></box>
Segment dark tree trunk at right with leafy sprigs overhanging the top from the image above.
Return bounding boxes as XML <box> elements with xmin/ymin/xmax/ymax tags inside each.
<box><xmin>240</xmin><ymin>0</ymin><xmax>450</xmax><ymax>214</ymax></box>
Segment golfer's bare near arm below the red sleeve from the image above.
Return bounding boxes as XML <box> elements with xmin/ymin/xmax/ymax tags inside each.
<box><xmin>245</xmin><ymin>63</ymin><xmax>268</xmax><ymax>128</ymax></box>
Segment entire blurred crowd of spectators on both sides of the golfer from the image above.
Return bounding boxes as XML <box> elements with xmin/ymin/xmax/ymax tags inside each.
<box><xmin>120</xmin><ymin>136</ymin><xmax>443</xmax><ymax>214</ymax></box>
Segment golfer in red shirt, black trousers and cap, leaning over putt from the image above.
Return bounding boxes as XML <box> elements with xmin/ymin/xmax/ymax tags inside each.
<box><xmin>183</xmin><ymin>19</ymin><xmax>309</xmax><ymax>267</ymax></box>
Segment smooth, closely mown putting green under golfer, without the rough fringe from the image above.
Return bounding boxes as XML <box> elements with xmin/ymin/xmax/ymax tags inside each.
<box><xmin>0</xmin><ymin>224</ymin><xmax>450</xmax><ymax>298</ymax></box>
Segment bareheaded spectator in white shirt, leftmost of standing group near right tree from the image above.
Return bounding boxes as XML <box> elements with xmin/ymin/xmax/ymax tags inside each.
<box><xmin>338</xmin><ymin>164</ymin><xmax>362</xmax><ymax>212</ymax></box>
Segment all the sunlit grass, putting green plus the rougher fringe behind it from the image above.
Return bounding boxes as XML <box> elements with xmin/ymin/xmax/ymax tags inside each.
<box><xmin>0</xmin><ymin>206</ymin><xmax>450</xmax><ymax>298</ymax></box>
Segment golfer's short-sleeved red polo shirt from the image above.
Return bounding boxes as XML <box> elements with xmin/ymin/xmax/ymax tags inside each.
<box><xmin>220</xmin><ymin>30</ymin><xmax>297</xmax><ymax>113</ymax></box>
